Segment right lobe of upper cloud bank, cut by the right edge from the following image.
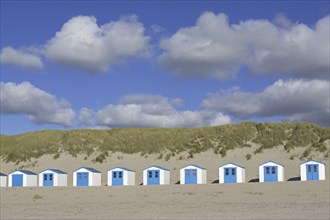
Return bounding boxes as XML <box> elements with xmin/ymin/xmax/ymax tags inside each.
<box><xmin>244</xmin><ymin>16</ymin><xmax>330</xmax><ymax>78</ymax></box>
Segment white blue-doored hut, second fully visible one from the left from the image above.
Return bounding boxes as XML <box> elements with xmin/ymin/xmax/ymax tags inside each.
<box><xmin>39</xmin><ymin>169</ymin><xmax>68</xmax><ymax>186</ymax></box>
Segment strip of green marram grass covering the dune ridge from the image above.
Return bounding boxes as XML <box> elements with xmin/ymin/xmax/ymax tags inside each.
<box><xmin>0</xmin><ymin>122</ymin><xmax>330</xmax><ymax>164</ymax></box>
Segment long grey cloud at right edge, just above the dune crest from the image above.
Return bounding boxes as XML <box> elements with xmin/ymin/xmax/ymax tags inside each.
<box><xmin>202</xmin><ymin>79</ymin><xmax>330</xmax><ymax>124</ymax></box>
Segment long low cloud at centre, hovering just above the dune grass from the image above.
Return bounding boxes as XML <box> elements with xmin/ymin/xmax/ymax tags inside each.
<box><xmin>85</xmin><ymin>94</ymin><xmax>230</xmax><ymax>127</ymax></box>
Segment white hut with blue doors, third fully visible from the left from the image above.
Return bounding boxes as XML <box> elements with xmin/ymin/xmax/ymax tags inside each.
<box><xmin>73</xmin><ymin>167</ymin><xmax>101</xmax><ymax>186</ymax></box>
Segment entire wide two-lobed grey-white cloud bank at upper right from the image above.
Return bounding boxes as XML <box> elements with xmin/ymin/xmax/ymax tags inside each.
<box><xmin>159</xmin><ymin>12</ymin><xmax>330</xmax><ymax>79</ymax></box>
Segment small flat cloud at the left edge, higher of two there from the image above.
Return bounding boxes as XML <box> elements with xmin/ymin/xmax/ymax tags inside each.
<box><xmin>0</xmin><ymin>47</ymin><xmax>43</xmax><ymax>69</ymax></box>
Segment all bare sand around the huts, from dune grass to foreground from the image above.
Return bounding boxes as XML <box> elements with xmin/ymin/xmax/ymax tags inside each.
<box><xmin>0</xmin><ymin>146</ymin><xmax>330</xmax><ymax>219</ymax></box>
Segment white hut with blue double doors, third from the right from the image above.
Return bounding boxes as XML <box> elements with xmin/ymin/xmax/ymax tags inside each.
<box><xmin>219</xmin><ymin>163</ymin><xmax>245</xmax><ymax>183</ymax></box>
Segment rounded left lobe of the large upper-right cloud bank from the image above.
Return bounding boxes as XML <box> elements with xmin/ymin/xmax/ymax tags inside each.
<box><xmin>159</xmin><ymin>12</ymin><xmax>247</xmax><ymax>79</ymax></box>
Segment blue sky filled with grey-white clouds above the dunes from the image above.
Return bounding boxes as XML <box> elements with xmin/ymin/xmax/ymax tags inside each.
<box><xmin>0</xmin><ymin>1</ymin><xmax>330</xmax><ymax>134</ymax></box>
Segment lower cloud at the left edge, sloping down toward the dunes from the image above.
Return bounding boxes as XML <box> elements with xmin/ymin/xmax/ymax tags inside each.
<box><xmin>0</xmin><ymin>82</ymin><xmax>75</xmax><ymax>126</ymax></box>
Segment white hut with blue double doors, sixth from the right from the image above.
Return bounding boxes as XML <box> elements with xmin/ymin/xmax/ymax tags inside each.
<box><xmin>108</xmin><ymin>167</ymin><xmax>135</xmax><ymax>186</ymax></box>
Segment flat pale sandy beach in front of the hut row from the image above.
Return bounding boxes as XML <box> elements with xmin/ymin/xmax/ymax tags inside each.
<box><xmin>1</xmin><ymin>181</ymin><xmax>329</xmax><ymax>219</ymax></box>
